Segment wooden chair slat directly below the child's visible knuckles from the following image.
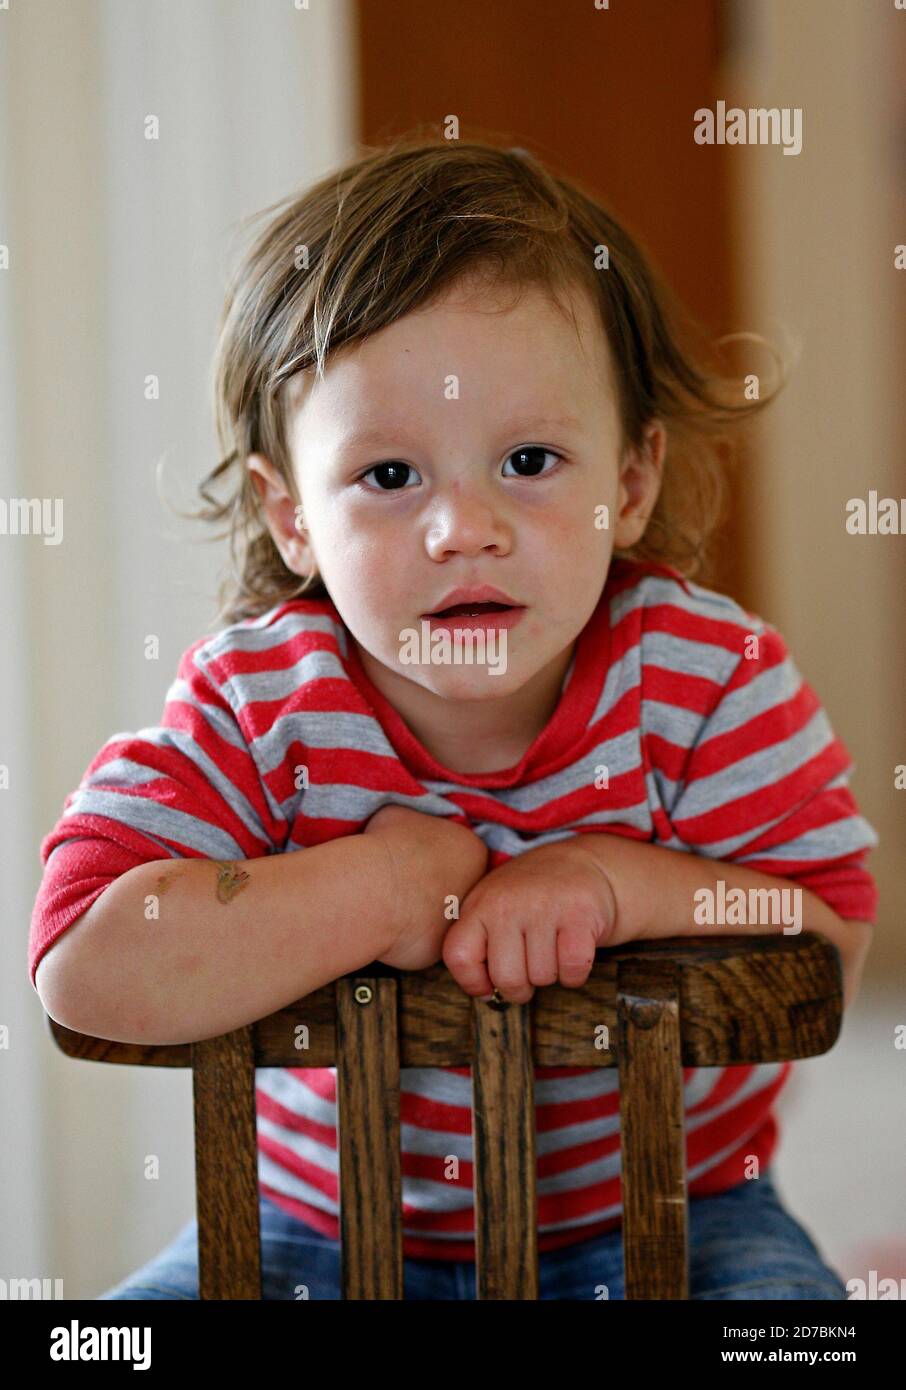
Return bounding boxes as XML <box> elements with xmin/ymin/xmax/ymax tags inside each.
<box><xmin>471</xmin><ymin>999</ymin><xmax>538</xmax><ymax>1300</ymax></box>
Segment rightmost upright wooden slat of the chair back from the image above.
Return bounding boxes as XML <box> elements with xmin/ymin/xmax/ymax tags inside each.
<box><xmin>617</xmin><ymin>960</ymin><xmax>689</xmax><ymax>1298</ymax></box>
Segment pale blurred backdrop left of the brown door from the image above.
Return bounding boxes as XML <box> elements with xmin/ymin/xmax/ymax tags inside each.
<box><xmin>0</xmin><ymin>0</ymin><xmax>357</xmax><ymax>1298</ymax></box>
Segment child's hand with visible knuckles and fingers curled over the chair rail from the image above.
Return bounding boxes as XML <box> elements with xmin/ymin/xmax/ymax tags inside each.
<box><xmin>443</xmin><ymin>835</ymin><xmax>617</xmax><ymax>1004</ymax></box>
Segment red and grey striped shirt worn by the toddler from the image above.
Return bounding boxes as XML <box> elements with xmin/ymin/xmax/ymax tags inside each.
<box><xmin>29</xmin><ymin>560</ymin><xmax>878</xmax><ymax>1259</ymax></box>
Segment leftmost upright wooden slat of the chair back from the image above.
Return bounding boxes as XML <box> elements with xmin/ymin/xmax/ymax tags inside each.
<box><xmin>190</xmin><ymin>1027</ymin><xmax>261</xmax><ymax>1298</ymax></box>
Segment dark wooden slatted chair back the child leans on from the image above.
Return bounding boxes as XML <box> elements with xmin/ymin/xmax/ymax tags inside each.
<box><xmin>49</xmin><ymin>931</ymin><xmax>842</xmax><ymax>1300</ymax></box>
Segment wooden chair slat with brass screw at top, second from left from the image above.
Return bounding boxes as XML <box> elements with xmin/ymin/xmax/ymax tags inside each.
<box><xmin>336</xmin><ymin>976</ymin><xmax>403</xmax><ymax>1298</ymax></box>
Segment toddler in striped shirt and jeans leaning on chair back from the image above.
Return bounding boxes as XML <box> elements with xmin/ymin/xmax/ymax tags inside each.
<box><xmin>29</xmin><ymin>138</ymin><xmax>878</xmax><ymax>1298</ymax></box>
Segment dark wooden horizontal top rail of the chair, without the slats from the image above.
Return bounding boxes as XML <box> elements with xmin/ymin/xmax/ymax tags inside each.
<box><xmin>47</xmin><ymin>931</ymin><xmax>842</xmax><ymax>1066</ymax></box>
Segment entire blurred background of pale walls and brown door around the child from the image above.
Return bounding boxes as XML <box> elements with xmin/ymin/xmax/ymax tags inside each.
<box><xmin>0</xmin><ymin>0</ymin><xmax>906</xmax><ymax>1298</ymax></box>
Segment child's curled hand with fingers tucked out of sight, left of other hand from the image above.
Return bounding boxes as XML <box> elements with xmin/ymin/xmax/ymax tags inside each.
<box><xmin>363</xmin><ymin>806</ymin><xmax>488</xmax><ymax>970</ymax></box>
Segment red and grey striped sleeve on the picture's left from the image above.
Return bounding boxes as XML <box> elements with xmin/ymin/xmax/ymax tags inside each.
<box><xmin>28</xmin><ymin>638</ymin><xmax>286</xmax><ymax>984</ymax></box>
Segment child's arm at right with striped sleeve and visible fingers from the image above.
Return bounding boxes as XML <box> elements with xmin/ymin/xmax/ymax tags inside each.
<box><xmin>443</xmin><ymin>614</ymin><xmax>878</xmax><ymax>1008</ymax></box>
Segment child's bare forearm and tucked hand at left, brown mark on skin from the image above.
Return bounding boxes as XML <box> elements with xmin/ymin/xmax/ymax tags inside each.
<box><xmin>35</xmin><ymin>806</ymin><xmax>488</xmax><ymax>1044</ymax></box>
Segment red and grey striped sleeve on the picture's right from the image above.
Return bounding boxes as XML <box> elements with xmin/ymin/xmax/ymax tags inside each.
<box><xmin>658</xmin><ymin>619</ymin><xmax>878</xmax><ymax>922</ymax></box>
